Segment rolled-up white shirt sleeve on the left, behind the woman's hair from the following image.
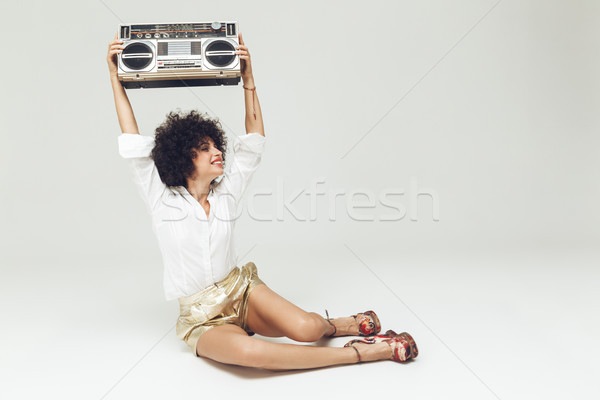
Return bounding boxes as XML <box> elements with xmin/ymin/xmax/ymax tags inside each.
<box><xmin>118</xmin><ymin>133</ymin><xmax>166</xmax><ymax>211</ymax></box>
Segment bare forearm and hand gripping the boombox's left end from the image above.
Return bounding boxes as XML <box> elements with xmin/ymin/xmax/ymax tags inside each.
<box><xmin>106</xmin><ymin>34</ymin><xmax>140</xmax><ymax>135</ymax></box>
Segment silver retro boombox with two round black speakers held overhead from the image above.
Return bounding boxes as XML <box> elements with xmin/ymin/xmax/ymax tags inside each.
<box><xmin>118</xmin><ymin>21</ymin><xmax>241</xmax><ymax>89</ymax></box>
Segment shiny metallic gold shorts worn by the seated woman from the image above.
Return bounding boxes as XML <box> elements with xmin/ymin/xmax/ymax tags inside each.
<box><xmin>176</xmin><ymin>262</ymin><xmax>264</xmax><ymax>356</ymax></box>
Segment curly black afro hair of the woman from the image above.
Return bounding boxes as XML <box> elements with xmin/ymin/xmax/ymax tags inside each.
<box><xmin>150</xmin><ymin>110</ymin><xmax>227</xmax><ymax>189</ymax></box>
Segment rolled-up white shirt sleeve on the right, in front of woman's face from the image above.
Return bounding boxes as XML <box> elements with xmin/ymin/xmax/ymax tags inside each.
<box><xmin>215</xmin><ymin>133</ymin><xmax>266</xmax><ymax>204</ymax></box>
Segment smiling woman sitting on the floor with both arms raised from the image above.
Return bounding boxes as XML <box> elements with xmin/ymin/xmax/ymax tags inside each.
<box><xmin>107</xmin><ymin>35</ymin><xmax>418</xmax><ymax>370</ymax></box>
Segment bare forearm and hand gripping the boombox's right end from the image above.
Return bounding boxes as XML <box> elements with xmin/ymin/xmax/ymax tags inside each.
<box><xmin>237</xmin><ymin>33</ymin><xmax>265</xmax><ymax>136</ymax></box>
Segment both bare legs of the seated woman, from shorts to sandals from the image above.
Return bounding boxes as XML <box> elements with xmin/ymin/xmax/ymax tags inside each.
<box><xmin>196</xmin><ymin>285</ymin><xmax>392</xmax><ymax>370</ymax></box>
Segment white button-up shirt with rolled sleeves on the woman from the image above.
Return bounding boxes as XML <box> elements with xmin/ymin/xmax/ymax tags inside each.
<box><xmin>118</xmin><ymin>133</ymin><xmax>265</xmax><ymax>300</ymax></box>
